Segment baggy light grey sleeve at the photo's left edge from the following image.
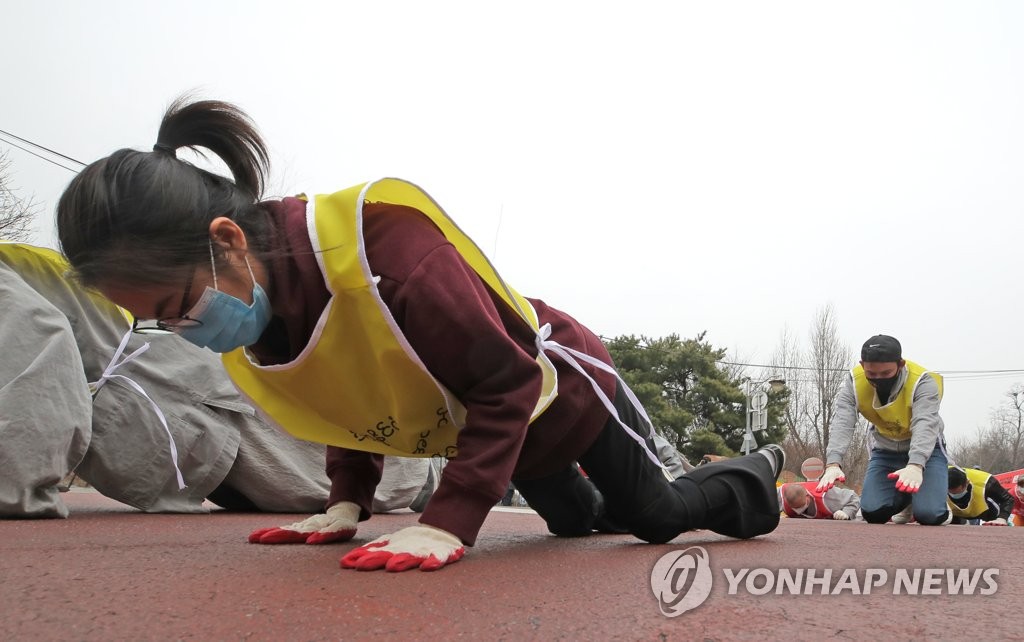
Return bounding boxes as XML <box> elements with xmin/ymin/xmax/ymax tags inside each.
<box><xmin>0</xmin><ymin>270</ymin><xmax>92</xmax><ymax>517</ymax></box>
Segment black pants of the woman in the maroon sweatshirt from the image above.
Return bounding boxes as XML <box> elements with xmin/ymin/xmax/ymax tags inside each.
<box><xmin>513</xmin><ymin>384</ymin><xmax>779</xmax><ymax>544</ymax></box>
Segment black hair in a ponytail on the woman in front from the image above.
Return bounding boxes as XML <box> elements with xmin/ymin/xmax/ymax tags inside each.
<box><xmin>56</xmin><ymin>95</ymin><xmax>272</xmax><ymax>287</ymax></box>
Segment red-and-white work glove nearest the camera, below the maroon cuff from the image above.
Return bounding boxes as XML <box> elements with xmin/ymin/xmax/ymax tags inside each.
<box><xmin>341</xmin><ymin>526</ymin><xmax>466</xmax><ymax>571</ymax></box>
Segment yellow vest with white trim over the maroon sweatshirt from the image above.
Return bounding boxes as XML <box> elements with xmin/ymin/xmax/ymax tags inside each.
<box><xmin>223</xmin><ymin>178</ymin><xmax>558</xmax><ymax>458</ymax></box>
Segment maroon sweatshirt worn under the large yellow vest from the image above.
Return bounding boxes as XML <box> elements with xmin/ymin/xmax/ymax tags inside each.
<box><xmin>251</xmin><ymin>198</ymin><xmax>615</xmax><ymax>545</ymax></box>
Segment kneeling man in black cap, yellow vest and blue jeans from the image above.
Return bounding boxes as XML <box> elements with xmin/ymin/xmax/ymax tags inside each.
<box><xmin>818</xmin><ymin>335</ymin><xmax>951</xmax><ymax>525</ymax></box>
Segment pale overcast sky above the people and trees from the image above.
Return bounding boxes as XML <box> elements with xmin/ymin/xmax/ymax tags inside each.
<box><xmin>0</xmin><ymin>0</ymin><xmax>1024</xmax><ymax>446</ymax></box>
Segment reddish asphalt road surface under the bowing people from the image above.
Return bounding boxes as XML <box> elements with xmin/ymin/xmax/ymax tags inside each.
<box><xmin>0</xmin><ymin>493</ymin><xmax>1024</xmax><ymax>642</ymax></box>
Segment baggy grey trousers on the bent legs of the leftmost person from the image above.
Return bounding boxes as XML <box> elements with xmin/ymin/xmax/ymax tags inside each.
<box><xmin>80</xmin><ymin>336</ymin><xmax>330</xmax><ymax>513</ymax></box>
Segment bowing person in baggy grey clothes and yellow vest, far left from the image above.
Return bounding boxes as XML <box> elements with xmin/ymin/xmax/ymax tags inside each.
<box><xmin>0</xmin><ymin>243</ymin><xmax>329</xmax><ymax>518</ymax></box>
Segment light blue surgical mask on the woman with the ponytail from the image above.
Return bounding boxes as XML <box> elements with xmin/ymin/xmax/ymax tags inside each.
<box><xmin>177</xmin><ymin>245</ymin><xmax>273</xmax><ymax>352</ymax></box>
